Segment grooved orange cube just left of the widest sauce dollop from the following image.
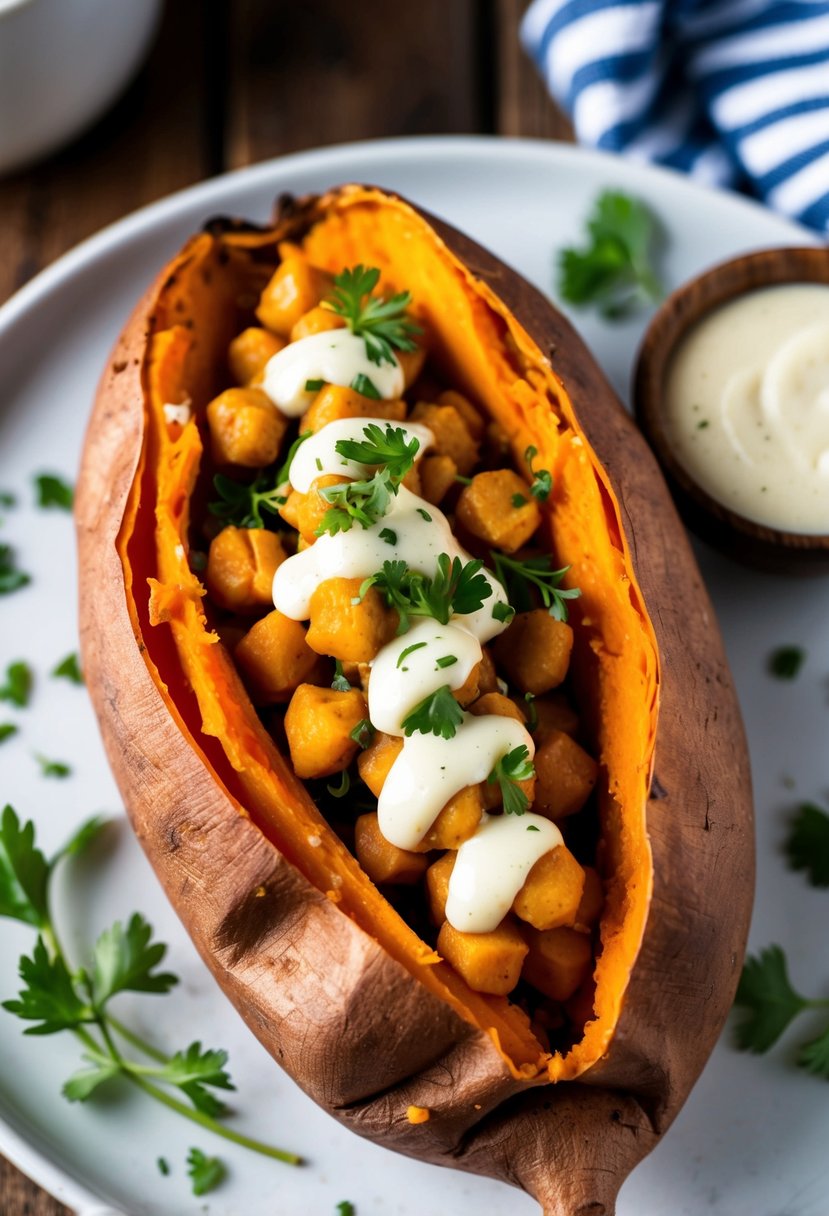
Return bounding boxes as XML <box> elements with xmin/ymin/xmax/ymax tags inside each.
<box><xmin>204</xmin><ymin>528</ymin><xmax>287</xmax><ymax>613</ymax></box>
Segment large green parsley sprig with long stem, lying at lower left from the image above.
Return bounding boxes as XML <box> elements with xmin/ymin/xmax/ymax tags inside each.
<box><xmin>0</xmin><ymin>806</ymin><xmax>300</xmax><ymax>1165</ymax></box>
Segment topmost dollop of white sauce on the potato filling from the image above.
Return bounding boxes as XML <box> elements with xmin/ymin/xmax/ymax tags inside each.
<box><xmin>261</xmin><ymin>330</ymin><xmax>404</xmax><ymax>418</ymax></box>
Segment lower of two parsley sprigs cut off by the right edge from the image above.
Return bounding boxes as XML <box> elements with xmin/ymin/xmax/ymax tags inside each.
<box><xmin>734</xmin><ymin>946</ymin><xmax>829</xmax><ymax>1079</ymax></box>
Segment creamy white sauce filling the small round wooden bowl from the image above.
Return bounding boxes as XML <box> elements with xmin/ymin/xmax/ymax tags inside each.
<box><xmin>665</xmin><ymin>283</ymin><xmax>829</xmax><ymax>534</ymax></box>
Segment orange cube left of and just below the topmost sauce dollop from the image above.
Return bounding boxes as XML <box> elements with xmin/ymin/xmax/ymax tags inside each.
<box><xmin>207</xmin><ymin>388</ymin><xmax>288</xmax><ymax>468</ymax></box>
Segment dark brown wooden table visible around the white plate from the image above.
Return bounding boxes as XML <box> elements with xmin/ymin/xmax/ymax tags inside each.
<box><xmin>0</xmin><ymin>0</ymin><xmax>564</xmax><ymax>1216</ymax></box>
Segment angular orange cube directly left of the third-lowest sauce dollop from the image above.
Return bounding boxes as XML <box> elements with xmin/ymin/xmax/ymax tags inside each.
<box><xmin>284</xmin><ymin>685</ymin><xmax>368</xmax><ymax>778</ymax></box>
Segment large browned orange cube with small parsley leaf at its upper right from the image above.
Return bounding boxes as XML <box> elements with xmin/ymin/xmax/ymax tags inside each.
<box><xmin>457</xmin><ymin>468</ymin><xmax>541</xmax><ymax>553</ymax></box>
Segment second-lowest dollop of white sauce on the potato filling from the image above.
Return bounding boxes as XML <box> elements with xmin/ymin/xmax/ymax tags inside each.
<box><xmin>370</xmin><ymin>710</ymin><xmax>535</xmax><ymax>846</ymax></box>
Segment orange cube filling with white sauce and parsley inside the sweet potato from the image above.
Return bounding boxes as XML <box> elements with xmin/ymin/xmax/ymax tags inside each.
<box><xmin>192</xmin><ymin>257</ymin><xmax>603</xmax><ymax>1049</ymax></box>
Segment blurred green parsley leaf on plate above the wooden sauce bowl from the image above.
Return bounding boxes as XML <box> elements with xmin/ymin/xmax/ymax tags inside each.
<box><xmin>558</xmin><ymin>190</ymin><xmax>661</xmax><ymax>320</ymax></box>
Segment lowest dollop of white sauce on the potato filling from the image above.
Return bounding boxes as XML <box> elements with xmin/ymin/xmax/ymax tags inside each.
<box><xmin>446</xmin><ymin>811</ymin><xmax>564</xmax><ymax>933</ymax></box>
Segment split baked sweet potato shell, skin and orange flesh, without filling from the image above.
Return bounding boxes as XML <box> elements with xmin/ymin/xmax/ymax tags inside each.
<box><xmin>77</xmin><ymin>186</ymin><xmax>752</xmax><ymax>1216</ymax></box>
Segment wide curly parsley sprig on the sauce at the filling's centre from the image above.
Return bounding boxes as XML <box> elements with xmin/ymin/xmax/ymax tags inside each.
<box><xmin>360</xmin><ymin>553</ymin><xmax>492</xmax><ymax>635</ymax></box>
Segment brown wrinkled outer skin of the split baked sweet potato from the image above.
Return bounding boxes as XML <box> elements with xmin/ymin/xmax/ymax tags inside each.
<box><xmin>75</xmin><ymin>189</ymin><xmax>754</xmax><ymax>1216</ymax></box>
